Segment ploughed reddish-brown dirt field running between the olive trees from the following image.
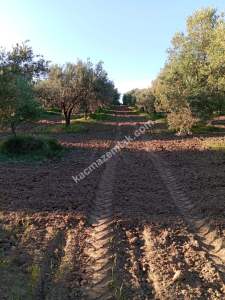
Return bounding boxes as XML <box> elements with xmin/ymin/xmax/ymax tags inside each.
<box><xmin>0</xmin><ymin>107</ymin><xmax>225</xmax><ymax>300</ymax></box>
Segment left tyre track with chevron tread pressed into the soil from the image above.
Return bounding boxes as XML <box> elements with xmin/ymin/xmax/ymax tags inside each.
<box><xmin>84</xmin><ymin>126</ymin><xmax>120</xmax><ymax>300</ymax></box>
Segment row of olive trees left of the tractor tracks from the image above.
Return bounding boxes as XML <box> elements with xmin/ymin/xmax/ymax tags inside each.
<box><xmin>0</xmin><ymin>42</ymin><xmax>120</xmax><ymax>133</ymax></box>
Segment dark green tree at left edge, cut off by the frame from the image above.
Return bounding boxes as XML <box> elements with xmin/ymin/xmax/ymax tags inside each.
<box><xmin>0</xmin><ymin>43</ymin><xmax>47</xmax><ymax>133</ymax></box>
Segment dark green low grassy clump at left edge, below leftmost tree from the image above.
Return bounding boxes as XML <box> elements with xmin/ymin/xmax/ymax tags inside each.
<box><xmin>0</xmin><ymin>135</ymin><xmax>64</xmax><ymax>161</ymax></box>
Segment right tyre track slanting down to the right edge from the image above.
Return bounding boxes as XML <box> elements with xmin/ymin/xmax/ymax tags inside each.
<box><xmin>146</xmin><ymin>148</ymin><xmax>225</xmax><ymax>282</ymax></box>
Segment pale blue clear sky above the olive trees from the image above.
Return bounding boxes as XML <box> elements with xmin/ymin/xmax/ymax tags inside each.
<box><xmin>0</xmin><ymin>0</ymin><xmax>225</xmax><ymax>93</ymax></box>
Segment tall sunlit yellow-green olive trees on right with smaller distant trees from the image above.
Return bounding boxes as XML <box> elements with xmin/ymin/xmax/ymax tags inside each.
<box><xmin>123</xmin><ymin>8</ymin><xmax>225</xmax><ymax>133</ymax></box>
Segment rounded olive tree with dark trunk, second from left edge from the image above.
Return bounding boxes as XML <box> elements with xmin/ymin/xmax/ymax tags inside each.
<box><xmin>36</xmin><ymin>60</ymin><xmax>119</xmax><ymax>126</ymax></box>
